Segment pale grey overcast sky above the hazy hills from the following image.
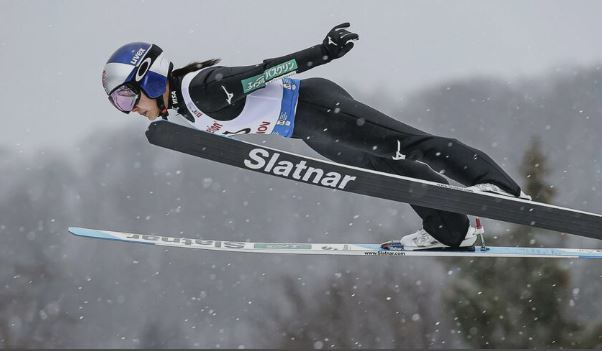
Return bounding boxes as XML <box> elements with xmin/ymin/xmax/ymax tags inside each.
<box><xmin>0</xmin><ymin>0</ymin><xmax>602</xmax><ymax>151</ymax></box>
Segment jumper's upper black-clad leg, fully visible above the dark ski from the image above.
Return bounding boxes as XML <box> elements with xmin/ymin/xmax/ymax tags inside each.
<box><xmin>293</xmin><ymin>78</ymin><xmax>520</xmax><ymax>196</ymax></box>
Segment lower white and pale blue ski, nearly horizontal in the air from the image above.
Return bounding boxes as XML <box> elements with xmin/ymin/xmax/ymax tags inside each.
<box><xmin>69</xmin><ymin>227</ymin><xmax>602</xmax><ymax>259</ymax></box>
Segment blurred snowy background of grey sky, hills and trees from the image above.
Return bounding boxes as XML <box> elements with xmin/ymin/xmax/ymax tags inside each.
<box><xmin>0</xmin><ymin>0</ymin><xmax>602</xmax><ymax>349</ymax></box>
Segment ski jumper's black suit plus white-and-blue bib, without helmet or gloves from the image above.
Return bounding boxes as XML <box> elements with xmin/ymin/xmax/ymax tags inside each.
<box><xmin>170</xmin><ymin>45</ymin><xmax>520</xmax><ymax>246</ymax></box>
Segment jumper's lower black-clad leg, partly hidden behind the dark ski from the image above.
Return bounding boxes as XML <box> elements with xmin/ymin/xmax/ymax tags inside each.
<box><xmin>296</xmin><ymin>126</ymin><xmax>469</xmax><ymax>247</ymax></box>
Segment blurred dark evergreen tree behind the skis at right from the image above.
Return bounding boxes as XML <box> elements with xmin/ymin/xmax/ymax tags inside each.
<box><xmin>444</xmin><ymin>139</ymin><xmax>601</xmax><ymax>348</ymax></box>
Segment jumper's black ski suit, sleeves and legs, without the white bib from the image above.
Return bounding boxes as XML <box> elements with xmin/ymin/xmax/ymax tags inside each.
<box><xmin>170</xmin><ymin>45</ymin><xmax>520</xmax><ymax>246</ymax></box>
